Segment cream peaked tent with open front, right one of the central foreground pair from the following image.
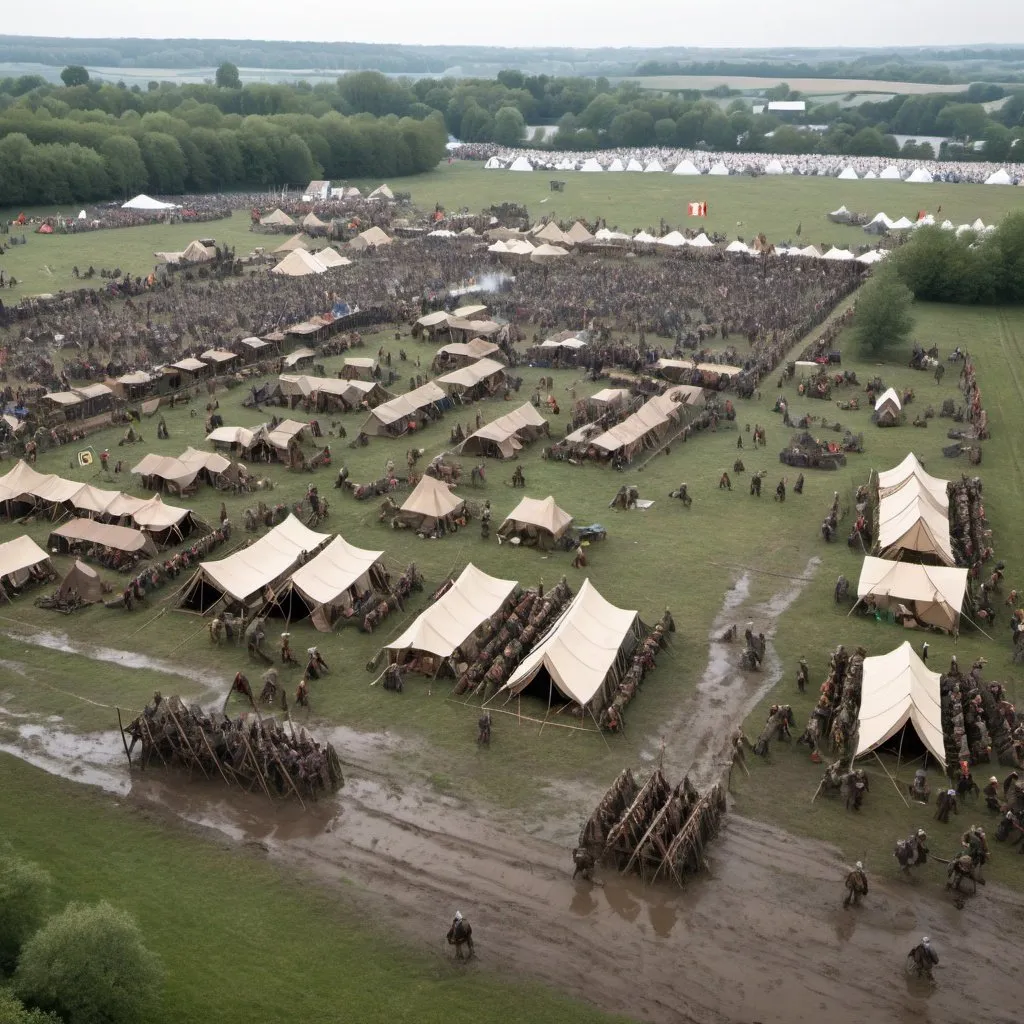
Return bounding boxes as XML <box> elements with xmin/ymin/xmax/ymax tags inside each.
<box><xmin>499</xmin><ymin>579</ymin><xmax>640</xmax><ymax>715</ymax></box>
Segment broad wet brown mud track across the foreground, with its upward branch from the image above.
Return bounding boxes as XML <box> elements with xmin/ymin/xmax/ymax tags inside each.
<box><xmin>0</xmin><ymin>566</ymin><xmax>1024</xmax><ymax>1024</ymax></box>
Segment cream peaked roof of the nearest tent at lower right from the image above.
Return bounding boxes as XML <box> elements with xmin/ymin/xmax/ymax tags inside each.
<box><xmin>855</xmin><ymin>641</ymin><xmax>946</xmax><ymax>767</ymax></box>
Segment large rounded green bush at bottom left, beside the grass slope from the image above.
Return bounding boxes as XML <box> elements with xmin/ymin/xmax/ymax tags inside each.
<box><xmin>14</xmin><ymin>903</ymin><xmax>163</xmax><ymax>1024</ymax></box>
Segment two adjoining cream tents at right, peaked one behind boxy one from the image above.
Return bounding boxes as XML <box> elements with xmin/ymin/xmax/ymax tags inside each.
<box><xmin>857</xmin><ymin>453</ymin><xmax>968</xmax><ymax>633</ymax></box>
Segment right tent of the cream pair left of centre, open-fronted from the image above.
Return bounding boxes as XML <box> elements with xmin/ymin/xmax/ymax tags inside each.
<box><xmin>275</xmin><ymin>537</ymin><xmax>387</xmax><ymax>633</ymax></box>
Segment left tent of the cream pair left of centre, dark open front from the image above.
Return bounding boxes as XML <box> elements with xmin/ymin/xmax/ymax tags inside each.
<box><xmin>180</xmin><ymin>515</ymin><xmax>331</xmax><ymax>614</ymax></box>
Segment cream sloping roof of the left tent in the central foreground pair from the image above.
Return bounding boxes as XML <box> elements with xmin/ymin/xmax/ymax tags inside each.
<box><xmin>387</xmin><ymin>565</ymin><xmax>519</xmax><ymax>657</ymax></box>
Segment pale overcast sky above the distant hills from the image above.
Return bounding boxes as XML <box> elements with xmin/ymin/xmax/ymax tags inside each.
<box><xmin>0</xmin><ymin>0</ymin><xmax>1024</xmax><ymax>47</ymax></box>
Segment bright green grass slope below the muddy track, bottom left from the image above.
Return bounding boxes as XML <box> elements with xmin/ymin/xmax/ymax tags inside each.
<box><xmin>0</xmin><ymin>754</ymin><xmax>612</xmax><ymax>1024</ymax></box>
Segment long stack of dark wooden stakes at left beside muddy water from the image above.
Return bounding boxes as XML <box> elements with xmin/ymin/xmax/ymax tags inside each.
<box><xmin>122</xmin><ymin>694</ymin><xmax>345</xmax><ymax>809</ymax></box>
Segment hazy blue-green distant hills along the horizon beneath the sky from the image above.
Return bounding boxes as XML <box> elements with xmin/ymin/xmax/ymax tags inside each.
<box><xmin>0</xmin><ymin>36</ymin><xmax>1024</xmax><ymax>84</ymax></box>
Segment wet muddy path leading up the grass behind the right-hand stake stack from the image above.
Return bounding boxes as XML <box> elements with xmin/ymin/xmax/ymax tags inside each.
<box><xmin>644</xmin><ymin>557</ymin><xmax>820</xmax><ymax>788</ymax></box>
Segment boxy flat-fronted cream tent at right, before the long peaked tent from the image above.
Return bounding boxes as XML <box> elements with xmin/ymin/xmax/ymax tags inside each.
<box><xmin>857</xmin><ymin>555</ymin><xmax>968</xmax><ymax>633</ymax></box>
